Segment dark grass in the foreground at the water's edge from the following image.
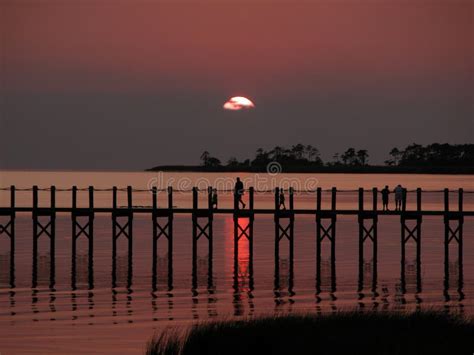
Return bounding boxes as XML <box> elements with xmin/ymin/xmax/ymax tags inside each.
<box><xmin>147</xmin><ymin>312</ymin><xmax>474</xmax><ymax>355</ymax></box>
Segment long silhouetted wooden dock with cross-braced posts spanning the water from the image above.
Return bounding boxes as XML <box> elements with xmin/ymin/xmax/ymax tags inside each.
<box><xmin>0</xmin><ymin>186</ymin><xmax>468</xmax><ymax>292</ymax></box>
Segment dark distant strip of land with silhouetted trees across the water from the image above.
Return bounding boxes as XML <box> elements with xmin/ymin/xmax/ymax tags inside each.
<box><xmin>146</xmin><ymin>143</ymin><xmax>474</xmax><ymax>174</ymax></box>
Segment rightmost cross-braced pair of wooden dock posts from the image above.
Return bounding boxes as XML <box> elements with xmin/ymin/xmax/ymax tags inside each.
<box><xmin>444</xmin><ymin>189</ymin><xmax>464</xmax><ymax>293</ymax></box>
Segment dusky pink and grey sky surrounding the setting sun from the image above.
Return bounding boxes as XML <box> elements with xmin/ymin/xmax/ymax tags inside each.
<box><xmin>0</xmin><ymin>0</ymin><xmax>474</xmax><ymax>170</ymax></box>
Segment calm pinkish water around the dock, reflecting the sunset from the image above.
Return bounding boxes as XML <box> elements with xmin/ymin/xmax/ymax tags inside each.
<box><xmin>0</xmin><ymin>171</ymin><xmax>474</xmax><ymax>354</ymax></box>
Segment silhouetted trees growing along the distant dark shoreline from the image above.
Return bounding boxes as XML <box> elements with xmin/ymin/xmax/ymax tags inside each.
<box><xmin>200</xmin><ymin>143</ymin><xmax>474</xmax><ymax>170</ymax></box>
